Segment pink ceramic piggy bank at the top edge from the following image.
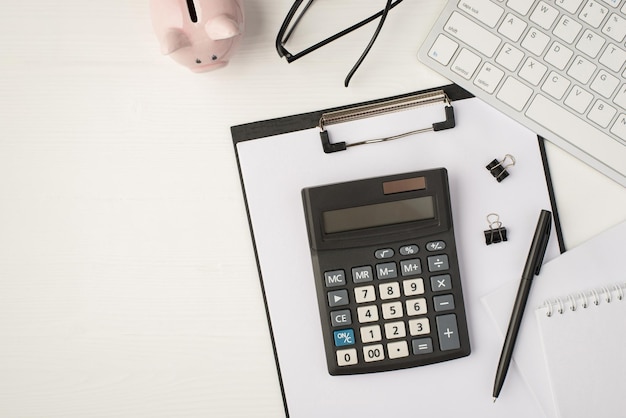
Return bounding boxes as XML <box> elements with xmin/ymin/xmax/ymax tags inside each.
<box><xmin>150</xmin><ymin>0</ymin><xmax>244</xmax><ymax>73</ymax></box>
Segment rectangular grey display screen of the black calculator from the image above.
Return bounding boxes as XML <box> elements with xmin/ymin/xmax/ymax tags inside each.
<box><xmin>322</xmin><ymin>196</ymin><xmax>435</xmax><ymax>234</ymax></box>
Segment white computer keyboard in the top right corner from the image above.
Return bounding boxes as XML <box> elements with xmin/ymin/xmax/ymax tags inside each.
<box><xmin>418</xmin><ymin>0</ymin><xmax>626</xmax><ymax>187</ymax></box>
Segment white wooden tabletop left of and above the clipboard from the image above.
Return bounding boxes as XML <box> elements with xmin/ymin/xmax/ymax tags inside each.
<box><xmin>0</xmin><ymin>0</ymin><xmax>620</xmax><ymax>418</ymax></box>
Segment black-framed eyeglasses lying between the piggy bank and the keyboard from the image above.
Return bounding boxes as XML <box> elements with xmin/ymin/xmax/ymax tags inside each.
<box><xmin>276</xmin><ymin>0</ymin><xmax>403</xmax><ymax>87</ymax></box>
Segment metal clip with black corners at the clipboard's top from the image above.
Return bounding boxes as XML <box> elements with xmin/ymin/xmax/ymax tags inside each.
<box><xmin>318</xmin><ymin>90</ymin><xmax>455</xmax><ymax>154</ymax></box>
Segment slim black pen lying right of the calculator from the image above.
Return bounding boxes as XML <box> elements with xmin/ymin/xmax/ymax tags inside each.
<box><xmin>493</xmin><ymin>210</ymin><xmax>552</xmax><ymax>402</ymax></box>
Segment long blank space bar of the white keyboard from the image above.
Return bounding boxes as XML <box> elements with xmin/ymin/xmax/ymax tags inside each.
<box><xmin>526</xmin><ymin>94</ymin><xmax>626</xmax><ymax>175</ymax></box>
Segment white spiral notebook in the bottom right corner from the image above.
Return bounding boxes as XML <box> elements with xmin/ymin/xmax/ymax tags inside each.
<box><xmin>535</xmin><ymin>280</ymin><xmax>626</xmax><ymax>418</ymax></box>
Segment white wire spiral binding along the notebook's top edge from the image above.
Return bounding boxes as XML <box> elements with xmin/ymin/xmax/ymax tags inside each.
<box><xmin>542</xmin><ymin>283</ymin><xmax>626</xmax><ymax>317</ymax></box>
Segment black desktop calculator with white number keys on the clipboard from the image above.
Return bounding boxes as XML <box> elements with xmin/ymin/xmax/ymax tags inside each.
<box><xmin>302</xmin><ymin>168</ymin><xmax>470</xmax><ymax>375</ymax></box>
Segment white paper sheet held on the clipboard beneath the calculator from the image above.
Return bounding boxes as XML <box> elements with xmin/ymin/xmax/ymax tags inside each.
<box><xmin>237</xmin><ymin>99</ymin><xmax>558</xmax><ymax>418</ymax></box>
